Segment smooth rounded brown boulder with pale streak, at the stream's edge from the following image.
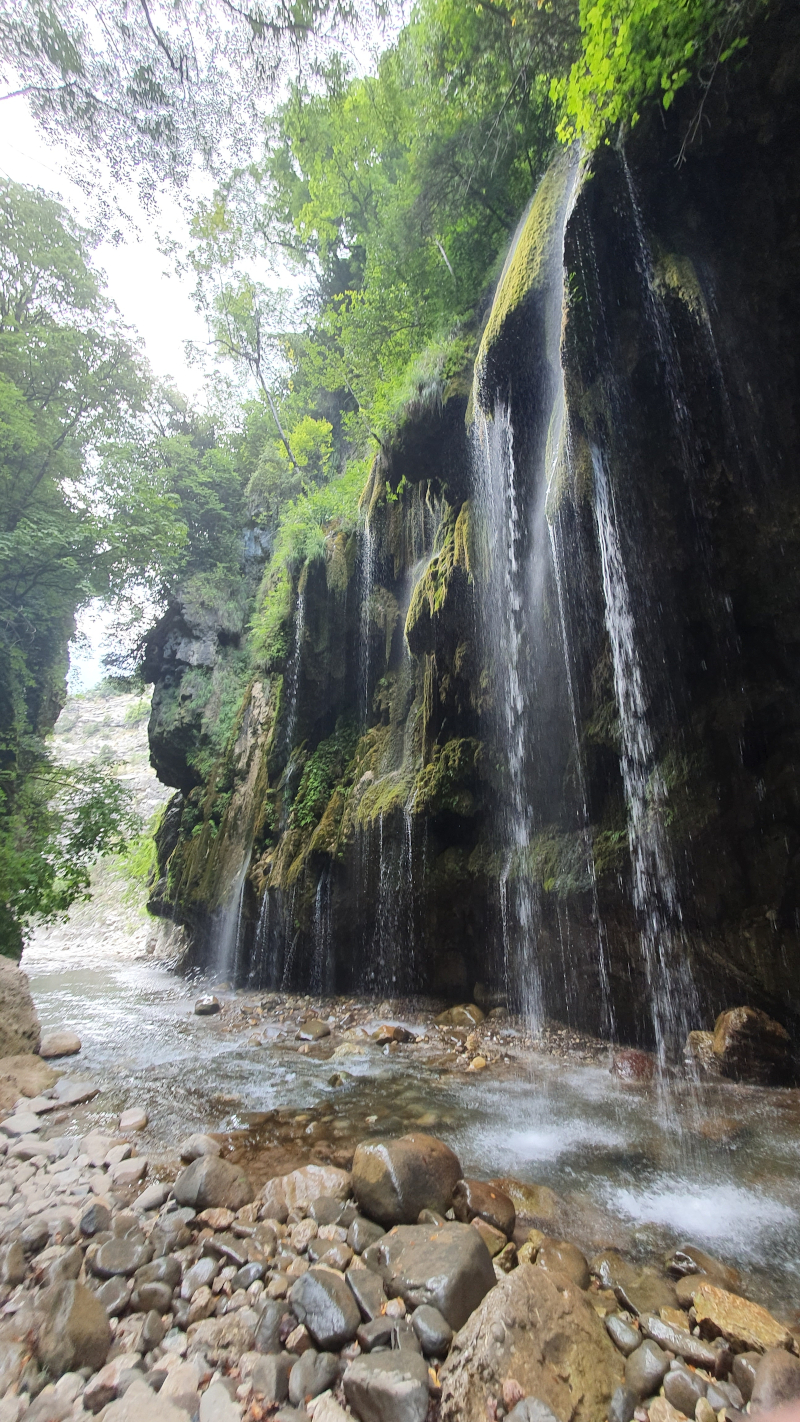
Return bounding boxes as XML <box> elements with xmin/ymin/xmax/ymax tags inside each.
<box><xmin>352</xmin><ymin>1132</ymin><xmax>462</xmax><ymax>1224</ymax></box>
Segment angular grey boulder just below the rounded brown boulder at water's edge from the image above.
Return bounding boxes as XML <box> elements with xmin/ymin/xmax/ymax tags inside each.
<box><xmin>362</xmin><ymin>1223</ymin><xmax>496</xmax><ymax>1330</ymax></box>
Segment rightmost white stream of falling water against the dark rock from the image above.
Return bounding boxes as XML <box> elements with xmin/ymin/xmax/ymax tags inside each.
<box><xmin>591</xmin><ymin>447</ymin><xmax>698</xmax><ymax>1062</ymax></box>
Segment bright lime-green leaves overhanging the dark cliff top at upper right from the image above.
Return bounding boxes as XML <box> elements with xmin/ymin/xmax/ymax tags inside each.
<box><xmin>551</xmin><ymin>0</ymin><xmax>764</xmax><ymax>144</ymax></box>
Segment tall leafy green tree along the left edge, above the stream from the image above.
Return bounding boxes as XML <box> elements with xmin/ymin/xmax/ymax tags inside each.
<box><xmin>0</xmin><ymin>182</ymin><xmax>180</xmax><ymax>951</ymax></box>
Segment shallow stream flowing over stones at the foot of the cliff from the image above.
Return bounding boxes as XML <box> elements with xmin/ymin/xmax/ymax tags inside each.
<box><xmin>23</xmin><ymin>934</ymin><xmax>800</xmax><ymax>1320</ymax></box>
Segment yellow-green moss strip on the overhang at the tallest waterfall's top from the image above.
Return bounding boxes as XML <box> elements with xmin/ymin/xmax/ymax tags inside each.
<box><xmin>476</xmin><ymin>155</ymin><xmax>571</xmax><ymax>367</ymax></box>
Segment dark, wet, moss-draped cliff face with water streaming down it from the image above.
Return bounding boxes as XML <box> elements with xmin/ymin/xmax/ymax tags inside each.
<box><xmin>148</xmin><ymin>0</ymin><xmax>800</xmax><ymax>1045</ymax></box>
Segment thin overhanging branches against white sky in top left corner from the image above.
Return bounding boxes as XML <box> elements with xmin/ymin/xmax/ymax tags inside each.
<box><xmin>0</xmin><ymin>0</ymin><xmax>395</xmax><ymax>206</ymax></box>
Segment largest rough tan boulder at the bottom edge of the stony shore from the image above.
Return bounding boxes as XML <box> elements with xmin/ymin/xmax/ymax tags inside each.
<box><xmin>439</xmin><ymin>1264</ymin><xmax>622</xmax><ymax>1422</ymax></box>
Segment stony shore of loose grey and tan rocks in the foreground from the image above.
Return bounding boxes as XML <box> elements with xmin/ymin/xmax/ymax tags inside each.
<box><xmin>0</xmin><ymin>1038</ymin><xmax>800</xmax><ymax>1422</ymax></box>
